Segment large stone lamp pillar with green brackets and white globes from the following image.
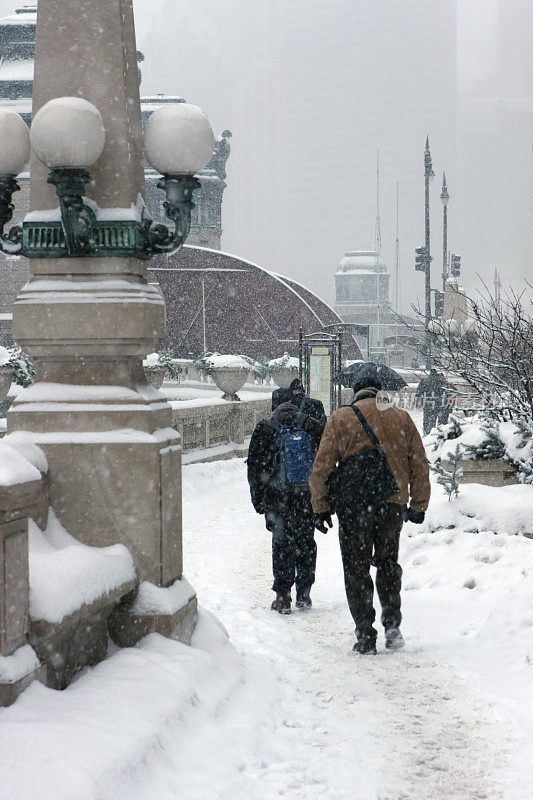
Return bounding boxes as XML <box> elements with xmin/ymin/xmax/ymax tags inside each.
<box><xmin>0</xmin><ymin>0</ymin><xmax>214</xmax><ymax>643</ymax></box>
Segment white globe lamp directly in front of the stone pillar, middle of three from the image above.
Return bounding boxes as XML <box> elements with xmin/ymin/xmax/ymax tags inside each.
<box><xmin>30</xmin><ymin>97</ymin><xmax>105</xmax><ymax>169</ymax></box>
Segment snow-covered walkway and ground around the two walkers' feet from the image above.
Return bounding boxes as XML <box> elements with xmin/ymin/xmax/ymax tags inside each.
<box><xmin>0</xmin><ymin>460</ymin><xmax>533</xmax><ymax>800</ymax></box>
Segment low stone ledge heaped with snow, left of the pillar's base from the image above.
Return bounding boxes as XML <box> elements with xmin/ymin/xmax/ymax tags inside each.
<box><xmin>0</xmin><ymin>431</ymin><xmax>136</xmax><ymax>692</ymax></box>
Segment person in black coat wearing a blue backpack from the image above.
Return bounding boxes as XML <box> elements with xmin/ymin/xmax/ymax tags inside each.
<box><xmin>247</xmin><ymin>389</ymin><xmax>324</xmax><ymax>614</ymax></box>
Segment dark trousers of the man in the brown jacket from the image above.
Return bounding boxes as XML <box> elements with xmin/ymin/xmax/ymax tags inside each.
<box><xmin>339</xmin><ymin>503</ymin><xmax>404</xmax><ymax>641</ymax></box>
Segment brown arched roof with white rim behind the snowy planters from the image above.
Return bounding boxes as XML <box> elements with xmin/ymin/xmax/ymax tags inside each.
<box><xmin>148</xmin><ymin>245</ymin><xmax>362</xmax><ymax>361</ymax></box>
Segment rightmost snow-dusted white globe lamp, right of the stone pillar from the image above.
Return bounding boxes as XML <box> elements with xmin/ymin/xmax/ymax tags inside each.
<box><xmin>144</xmin><ymin>103</ymin><xmax>215</xmax><ymax>175</ymax></box>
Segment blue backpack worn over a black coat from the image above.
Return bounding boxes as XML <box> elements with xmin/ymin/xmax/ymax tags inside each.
<box><xmin>268</xmin><ymin>414</ymin><xmax>315</xmax><ymax>490</ymax></box>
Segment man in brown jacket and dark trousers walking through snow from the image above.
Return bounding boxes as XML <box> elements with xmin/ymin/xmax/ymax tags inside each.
<box><xmin>309</xmin><ymin>364</ymin><xmax>431</xmax><ymax>654</ymax></box>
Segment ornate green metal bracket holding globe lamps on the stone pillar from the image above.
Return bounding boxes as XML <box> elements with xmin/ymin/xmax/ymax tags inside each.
<box><xmin>0</xmin><ymin>168</ymin><xmax>200</xmax><ymax>261</ymax></box>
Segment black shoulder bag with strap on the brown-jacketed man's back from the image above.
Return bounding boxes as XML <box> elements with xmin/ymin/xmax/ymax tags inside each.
<box><xmin>327</xmin><ymin>405</ymin><xmax>399</xmax><ymax>525</ymax></box>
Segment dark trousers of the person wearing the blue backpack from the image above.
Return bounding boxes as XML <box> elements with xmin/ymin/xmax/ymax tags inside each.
<box><xmin>266</xmin><ymin>496</ymin><xmax>316</xmax><ymax>597</ymax></box>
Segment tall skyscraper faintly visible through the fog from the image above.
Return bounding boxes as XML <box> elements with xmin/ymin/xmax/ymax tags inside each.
<box><xmin>236</xmin><ymin>0</ymin><xmax>457</xmax><ymax>306</ymax></box>
